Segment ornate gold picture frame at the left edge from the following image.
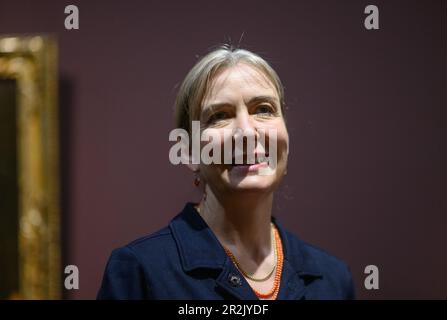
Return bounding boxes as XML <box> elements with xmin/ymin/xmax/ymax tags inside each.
<box><xmin>0</xmin><ymin>35</ymin><xmax>61</xmax><ymax>299</ymax></box>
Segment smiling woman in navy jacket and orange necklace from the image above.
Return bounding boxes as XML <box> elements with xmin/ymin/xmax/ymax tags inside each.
<box><xmin>98</xmin><ymin>46</ymin><xmax>354</xmax><ymax>299</ymax></box>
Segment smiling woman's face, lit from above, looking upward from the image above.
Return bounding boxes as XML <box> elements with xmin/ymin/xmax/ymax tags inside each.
<box><xmin>199</xmin><ymin>63</ymin><xmax>289</xmax><ymax>195</ymax></box>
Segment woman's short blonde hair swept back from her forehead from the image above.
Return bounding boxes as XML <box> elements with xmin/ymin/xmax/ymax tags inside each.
<box><xmin>175</xmin><ymin>44</ymin><xmax>284</xmax><ymax>132</ymax></box>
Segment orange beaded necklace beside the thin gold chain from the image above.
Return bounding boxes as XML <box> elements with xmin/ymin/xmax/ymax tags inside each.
<box><xmin>224</xmin><ymin>225</ymin><xmax>284</xmax><ymax>300</ymax></box>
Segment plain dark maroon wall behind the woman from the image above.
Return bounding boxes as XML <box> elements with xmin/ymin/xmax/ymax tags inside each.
<box><xmin>0</xmin><ymin>0</ymin><xmax>447</xmax><ymax>299</ymax></box>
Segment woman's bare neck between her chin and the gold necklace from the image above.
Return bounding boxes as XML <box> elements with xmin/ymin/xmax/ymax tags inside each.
<box><xmin>197</xmin><ymin>186</ymin><xmax>273</xmax><ymax>263</ymax></box>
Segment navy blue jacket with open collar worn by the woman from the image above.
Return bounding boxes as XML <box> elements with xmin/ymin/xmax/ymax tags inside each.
<box><xmin>97</xmin><ymin>203</ymin><xmax>354</xmax><ymax>300</ymax></box>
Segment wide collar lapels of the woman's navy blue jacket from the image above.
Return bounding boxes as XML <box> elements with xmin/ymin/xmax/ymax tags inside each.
<box><xmin>170</xmin><ymin>203</ymin><xmax>321</xmax><ymax>300</ymax></box>
